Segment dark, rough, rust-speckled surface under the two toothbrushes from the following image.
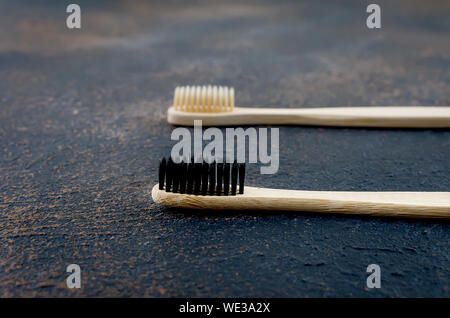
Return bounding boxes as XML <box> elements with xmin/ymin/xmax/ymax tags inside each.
<box><xmin>0</xmin><ymin>0</ymin><xmax>450</xmax><ymax>297</ymax></box>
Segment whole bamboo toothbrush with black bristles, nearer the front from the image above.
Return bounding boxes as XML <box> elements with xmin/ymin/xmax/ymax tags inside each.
<box><xmin>152</xmin><ymin>159</ymin><xmax>450</xmax><ymax>218</ymax></box>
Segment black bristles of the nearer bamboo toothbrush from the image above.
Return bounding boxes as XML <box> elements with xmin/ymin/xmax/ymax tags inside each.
<box><xmin>159</xmin><ymin>157</ymin><xmax>245</xmax><ymax>196</ymax></box>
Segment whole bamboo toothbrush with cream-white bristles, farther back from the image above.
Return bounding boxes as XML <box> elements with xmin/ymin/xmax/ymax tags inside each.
<box><xmin>167</xmin><ymin>86</ymin><xmax>450</xmax><ymax>128</ymax></box>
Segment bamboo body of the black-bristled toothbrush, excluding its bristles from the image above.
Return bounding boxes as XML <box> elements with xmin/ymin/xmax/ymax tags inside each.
<box><xmin>152</xmin><ymin>185</ymin><xmax>450</xmax><ymax>218</ymax></box>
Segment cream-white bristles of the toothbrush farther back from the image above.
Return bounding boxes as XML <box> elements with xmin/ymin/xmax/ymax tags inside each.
<box><xmin>173</xmin><ymin>85</ymin><xmax>234</xmax><ymax>113</ymax></box>
